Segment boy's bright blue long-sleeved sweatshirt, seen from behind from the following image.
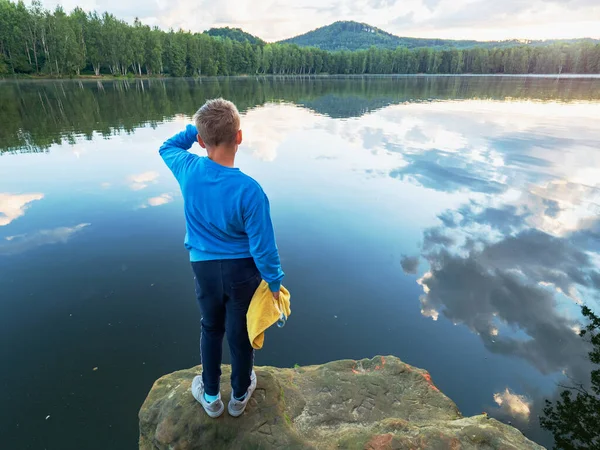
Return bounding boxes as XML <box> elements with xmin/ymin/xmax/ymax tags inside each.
<box><xmin>159</xmin><ymin>125</ymin><xmax>284</xmax><ymax>292</ymax></box>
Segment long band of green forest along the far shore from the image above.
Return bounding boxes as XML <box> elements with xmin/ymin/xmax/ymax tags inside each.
<box><xmin>0</xmin><ymin>0</ymin><xmax>600</xmax><ymax>77</ymax></box>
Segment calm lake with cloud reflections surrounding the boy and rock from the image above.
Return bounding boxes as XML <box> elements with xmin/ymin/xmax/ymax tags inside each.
<box><xmin>0</xmin><ymin>77</ymin><xmax>600</xmax><ymax>450</ymax></box>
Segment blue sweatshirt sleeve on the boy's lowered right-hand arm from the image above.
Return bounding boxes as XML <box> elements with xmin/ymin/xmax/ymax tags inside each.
<box><xmin>244</xmin><ymin>188</ymin><xmax>284</xmax><ymax>292</ymax></box>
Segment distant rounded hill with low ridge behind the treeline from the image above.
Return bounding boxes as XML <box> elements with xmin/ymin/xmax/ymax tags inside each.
<box><xmin>281</xmin><ymin>21</ymin><xmax>593</xmax><ymax>51</ymax></box>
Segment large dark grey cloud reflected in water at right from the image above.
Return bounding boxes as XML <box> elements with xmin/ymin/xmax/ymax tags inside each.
<box><xmin>419</xmin><ymin>222</ymin><xmax>600</xmax><ymax>372</ymax></box>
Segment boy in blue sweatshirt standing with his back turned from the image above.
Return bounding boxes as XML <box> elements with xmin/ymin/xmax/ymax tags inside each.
<box><xmin>159</xmin><ymin>98</ymin><xmax>284</xmax><ymax>418</ymax></box>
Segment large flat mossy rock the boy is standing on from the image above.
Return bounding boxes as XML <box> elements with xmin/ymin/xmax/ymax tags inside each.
<box><xmin>139</xmin><ymin>356</ymin><xmax>543</xmax><ymax>450</ymax></box>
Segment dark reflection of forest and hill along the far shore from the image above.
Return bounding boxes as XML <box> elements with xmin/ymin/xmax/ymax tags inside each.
<box><xmin>0</xmin><ymin>77</ymin><xmax>600</xmax><ymax>152</ymax></box>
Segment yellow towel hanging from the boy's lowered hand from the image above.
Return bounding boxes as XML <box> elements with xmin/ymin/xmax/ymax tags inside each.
<box><xmin>246</xmin><ymin>280</ymin><xmax>292</xmax><ymax>350</ymax></box>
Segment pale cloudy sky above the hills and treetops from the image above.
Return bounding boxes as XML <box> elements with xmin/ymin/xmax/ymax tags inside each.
<box><xmin>28</xmin><ymin>0</ymin><xmax>600</xmax><ymax>42</ymax></box>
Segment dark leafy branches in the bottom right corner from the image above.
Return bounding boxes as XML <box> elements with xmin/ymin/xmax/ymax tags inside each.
<box><xmin>540</xmin><ymin>306</ymin><xmax>600</xmax><ymax>450</ymax></box>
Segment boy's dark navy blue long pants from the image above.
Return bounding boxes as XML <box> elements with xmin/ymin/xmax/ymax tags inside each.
<box><xmin>192</xmin><ymin>258</ymin><xmax>261</xmax><ymax>398</ymax></box>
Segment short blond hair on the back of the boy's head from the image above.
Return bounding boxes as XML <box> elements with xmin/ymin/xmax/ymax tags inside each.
<box><xmin>194</xmin><ymin>98</ymin><xmax>240</xmax><ymax>147</ymax></box>
